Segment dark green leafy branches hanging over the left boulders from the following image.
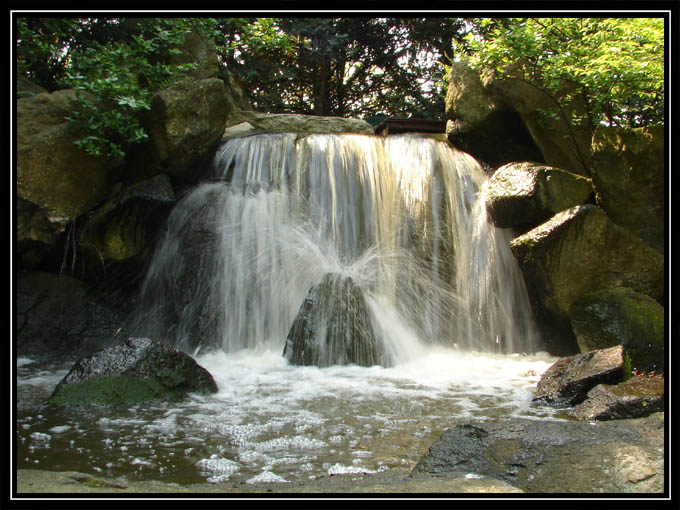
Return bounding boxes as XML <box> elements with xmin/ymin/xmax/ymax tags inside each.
<box><xmin>17</xmin><ymin>18</ymin><xmax>212</xmax><ymax>158</ymax></box>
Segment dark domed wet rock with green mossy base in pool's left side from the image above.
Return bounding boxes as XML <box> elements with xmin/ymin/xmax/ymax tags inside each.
<box><xmin>49</xmin><ymin>338</ymin><xmax>217</xmax><ymax>406</ymax></box>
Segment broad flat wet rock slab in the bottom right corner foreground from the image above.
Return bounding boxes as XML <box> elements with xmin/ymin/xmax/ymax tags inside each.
<box><xmin>414</xmin><ymin>413</ymin><xmax>664</xmax><ymax>493</ymax></box>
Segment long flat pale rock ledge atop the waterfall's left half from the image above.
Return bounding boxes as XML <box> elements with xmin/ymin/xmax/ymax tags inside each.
<box><xmin>222</xmin><ymin>112</ymin><xmax>373</xmax><ymax>140</ymax></box>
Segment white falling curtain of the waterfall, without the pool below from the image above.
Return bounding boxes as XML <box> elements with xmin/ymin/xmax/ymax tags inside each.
<box><xmin>133</xmin><ymin>134</ymin><xmax>536</xmax><ymax>363</ymax></box>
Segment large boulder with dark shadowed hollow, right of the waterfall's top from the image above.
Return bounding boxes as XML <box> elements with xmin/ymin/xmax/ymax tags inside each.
<box><xmin>446</xmin><ymin>61</ymin><xmax>592</xmax><ymax>175</ymax></box>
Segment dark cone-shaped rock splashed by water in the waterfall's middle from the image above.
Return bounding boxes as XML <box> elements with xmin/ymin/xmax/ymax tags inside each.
<box><xmin>283</xmin><ymin>273</ymin><xmax>392</xmax><ymax>367</ymax></box>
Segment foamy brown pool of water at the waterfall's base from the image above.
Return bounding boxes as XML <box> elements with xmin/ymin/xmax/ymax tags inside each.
<box><xmin>15</xmin><ymin>347</ymin><xmax>560</xmax><ymax>484</ymax></box>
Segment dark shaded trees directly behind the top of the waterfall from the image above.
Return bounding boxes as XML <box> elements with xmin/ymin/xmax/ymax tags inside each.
<box><xmin>212</xmin><ymin>18</ymin><xmax>464</xmax><ymax>118</ymax></box>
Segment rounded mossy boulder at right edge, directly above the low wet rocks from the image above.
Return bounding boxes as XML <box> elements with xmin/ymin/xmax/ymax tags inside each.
<box><xmin>569</xmin><ymin>287</ymin><xmax>665</xmax><ymax>371</ymax></box>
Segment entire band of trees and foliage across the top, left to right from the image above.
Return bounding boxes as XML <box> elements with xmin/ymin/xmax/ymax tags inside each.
<box><xmin>15</xmin><ymin>17</ymin><xmax>665</xmax><ymax>156</ymax></box>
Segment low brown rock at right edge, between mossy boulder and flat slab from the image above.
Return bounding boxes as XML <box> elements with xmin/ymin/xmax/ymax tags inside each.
<box><xmin>569</xmin><ymin>376</ymin><xmax>665</xmax><ymax>420</ymax></box>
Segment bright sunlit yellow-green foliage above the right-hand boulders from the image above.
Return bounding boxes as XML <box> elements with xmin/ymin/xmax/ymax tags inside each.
<box><xmin>466</xmin><ymin>18</ymin><xmax>665</xmax><ymax>127</ymax></box>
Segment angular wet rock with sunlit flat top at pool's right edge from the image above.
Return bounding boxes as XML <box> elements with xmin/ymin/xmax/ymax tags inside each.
<box><xmin>534</xmin><ymin>345</ymin><xmax>630</xmax><ymax>406</ymax></box>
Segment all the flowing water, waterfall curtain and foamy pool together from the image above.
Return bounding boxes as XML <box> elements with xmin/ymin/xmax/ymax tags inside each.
<box><xmin>17</xmin><ymin>134</ymin><xmax>557</xmax><ymax>483</ymax></box>
